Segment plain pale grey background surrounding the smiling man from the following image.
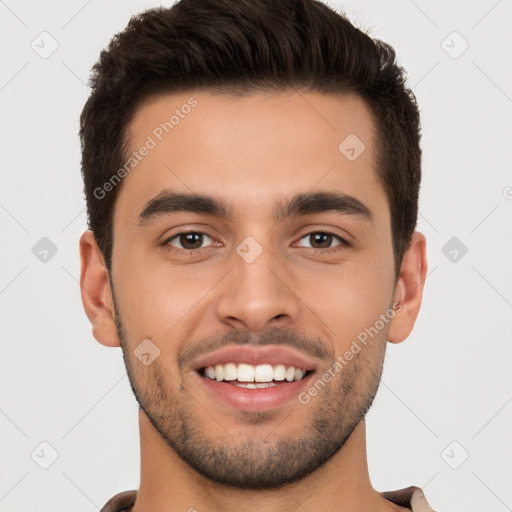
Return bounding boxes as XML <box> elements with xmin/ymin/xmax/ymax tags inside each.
<box><xmin>0</xmin><ymin>0</ymin><xmax>512</xmax><ymax>512</ymax></box>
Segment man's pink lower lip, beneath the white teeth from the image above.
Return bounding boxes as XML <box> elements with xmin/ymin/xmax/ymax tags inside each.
<box><xmin>194</xmin><ymin>372</ymin><xmax>314</xmax><ymax>411</ymax></box>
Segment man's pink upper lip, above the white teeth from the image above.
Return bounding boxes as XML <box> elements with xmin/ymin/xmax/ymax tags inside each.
<box><xmin>193</xmin><ymin>345</ymin><xmax>317</xmax><ymax>371</ymax></box>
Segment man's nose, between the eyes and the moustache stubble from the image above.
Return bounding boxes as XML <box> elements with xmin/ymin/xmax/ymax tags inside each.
<box><xmin>216</xmin><ymin>237</ymin><xmax>300</xmax><ymax>332</ymax></box>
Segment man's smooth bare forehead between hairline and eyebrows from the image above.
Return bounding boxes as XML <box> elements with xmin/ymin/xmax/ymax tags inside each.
<box><xmin>114</xmin><ymin>90</ymin><xmax>387</xmax><ymax>226</ymax></box>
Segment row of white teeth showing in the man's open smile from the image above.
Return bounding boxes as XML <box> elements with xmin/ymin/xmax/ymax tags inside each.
<box><xmin>204</xmin><ymin>363</ymin><xmax>306</xmax><ymax>382</ymax></box>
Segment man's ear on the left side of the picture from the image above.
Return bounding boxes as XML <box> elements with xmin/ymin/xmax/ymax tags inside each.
<box><xmin>80</xmin><ymin>230</ymin><xmax>121</xmax><ymax>347</ymax></box>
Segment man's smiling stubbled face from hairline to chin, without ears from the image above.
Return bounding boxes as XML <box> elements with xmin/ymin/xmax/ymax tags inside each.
<box><xmin>107</xmin><ymin>91</ymin><xmax>396</xmax><ymax>488</ymax></box>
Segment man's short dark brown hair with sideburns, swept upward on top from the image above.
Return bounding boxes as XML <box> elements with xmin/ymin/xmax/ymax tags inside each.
<box><xmin>80</xmin><ymin>0</ymin><xmax>421</xmax><ymax>277</ymax></box>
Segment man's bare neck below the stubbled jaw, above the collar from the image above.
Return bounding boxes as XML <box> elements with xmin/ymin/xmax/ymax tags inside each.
<box><xmin>133</xmin><ymin>410</ymin><xmax>405</xmax><ymax>512</ymax></box>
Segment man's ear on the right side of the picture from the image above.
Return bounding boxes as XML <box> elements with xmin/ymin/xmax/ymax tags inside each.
<box><xmin>388</xmin><ymin>231</ymin><xmax>427</xmax><ymax>343</ymax></box>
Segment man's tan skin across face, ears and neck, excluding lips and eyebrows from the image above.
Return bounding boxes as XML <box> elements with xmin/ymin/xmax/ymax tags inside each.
<box><xmin>80</xmin><ymin>90</ymin><xmax>427</xmax><ymax>512</ymax></box>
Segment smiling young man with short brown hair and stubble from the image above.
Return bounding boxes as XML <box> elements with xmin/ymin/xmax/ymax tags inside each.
<box><xmin>80</xmin><ymin>0</ymin><xmax>432</xmax><ymax>512</ymax></box>
